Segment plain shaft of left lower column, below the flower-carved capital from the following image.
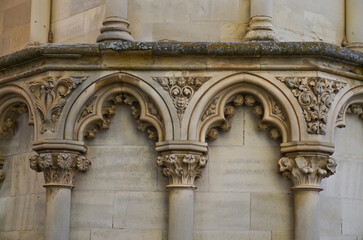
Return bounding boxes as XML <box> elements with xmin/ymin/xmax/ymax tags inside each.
<box><xmin>45</xmin><ymin>187</ymin><xmax>71</xmax><ymax>240</ymax></box>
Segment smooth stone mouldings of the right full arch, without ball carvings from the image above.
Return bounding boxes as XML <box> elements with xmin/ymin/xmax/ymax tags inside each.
<box><xmin>187</xmin><ymin>73</ymin><xmax>304</xmax><ymax>143</ymax></box>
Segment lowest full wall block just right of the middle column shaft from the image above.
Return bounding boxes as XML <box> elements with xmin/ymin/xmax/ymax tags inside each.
<box><xmin>194</xmin><ymin>192</ymin><xmax>250</xmax><ymax>230</ymax></box>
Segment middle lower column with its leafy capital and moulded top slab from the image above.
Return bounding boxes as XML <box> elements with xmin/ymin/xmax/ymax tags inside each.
<box><xmin>157</xmin><ymin>141</ymin><xmax>207</xmax><ymax>240</ymax></box>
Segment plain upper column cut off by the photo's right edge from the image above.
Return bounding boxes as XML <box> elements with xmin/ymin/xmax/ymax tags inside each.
<box><xmin>345</xmin><ymin>0</ymin><xmax>363</xmax><ymax>52</ymax></box>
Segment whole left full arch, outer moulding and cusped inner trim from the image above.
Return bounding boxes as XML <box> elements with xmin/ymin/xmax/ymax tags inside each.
<box><xmin>64</xmin><ymin>73</ymin><xmax>174</xmax><ymax>141</ymax></box>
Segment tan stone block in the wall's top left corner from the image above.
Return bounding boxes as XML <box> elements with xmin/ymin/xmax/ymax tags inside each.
<box><xmin>2</xmin><ymin>1</ymin><xmax>31</xmax><ymax>32</ymax></box>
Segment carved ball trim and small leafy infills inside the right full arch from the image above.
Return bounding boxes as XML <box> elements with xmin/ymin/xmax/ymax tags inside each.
<box><xmin>205</xmin><ymin>94</ymin><xmax>286</xmax><ymax>140</ymax></box>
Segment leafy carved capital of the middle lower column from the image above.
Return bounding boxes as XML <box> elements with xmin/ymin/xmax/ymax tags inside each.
<box><xmin>157</xmin><ymin>153</ymin><xmax>208</xmax><ymax>186</ymax></box>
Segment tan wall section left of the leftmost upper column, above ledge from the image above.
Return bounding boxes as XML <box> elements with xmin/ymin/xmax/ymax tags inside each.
<box><xmin>0</xmin><ymin>0</ymin><xmax>31</xmax><ymax>56</ymax></box>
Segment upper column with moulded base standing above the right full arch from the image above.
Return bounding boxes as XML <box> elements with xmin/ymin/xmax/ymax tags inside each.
<box><xmin>243</xmin><ymin>0</ymin><xmax>278</xmax><ymax>42</ymax></box>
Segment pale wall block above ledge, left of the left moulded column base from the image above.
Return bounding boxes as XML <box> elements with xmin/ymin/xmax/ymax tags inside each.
<box><xmin>51</xmin><ymin>13</ymin><xmax>84</xmax><ymax>42</ymax></box>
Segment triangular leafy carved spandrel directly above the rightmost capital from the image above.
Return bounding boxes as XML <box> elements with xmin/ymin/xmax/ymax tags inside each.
<box><xmin>277</xmin><ymin>77</ymin><xmax>346</xmax><ymax>135</ymax></box>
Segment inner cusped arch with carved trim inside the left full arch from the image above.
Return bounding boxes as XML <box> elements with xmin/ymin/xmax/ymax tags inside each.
<box><xmin>76</xmin><ymin>84</ymin><xmax>163</xmax><ymax>140</ymax></box>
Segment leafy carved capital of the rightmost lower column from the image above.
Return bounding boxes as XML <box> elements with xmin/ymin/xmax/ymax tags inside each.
<box><xmin>278</xmin><ymin>154</ymin><xmax>336</xmax><ymax>191</ymax></box>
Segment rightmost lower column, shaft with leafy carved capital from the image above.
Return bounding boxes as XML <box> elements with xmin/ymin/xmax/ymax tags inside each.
<box><xmin>279</xmin><ymin>153</ymin><xmax>336</xmax><ymax>240</ymax></box>
